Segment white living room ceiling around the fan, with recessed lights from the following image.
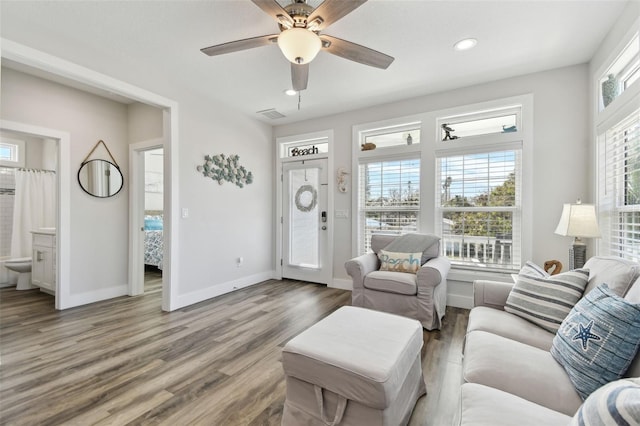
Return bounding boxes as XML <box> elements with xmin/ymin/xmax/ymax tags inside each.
<box><xmin>0</xmin><ymin>0</ymin><xmax>638</xmax><ymax>125</ymax></box>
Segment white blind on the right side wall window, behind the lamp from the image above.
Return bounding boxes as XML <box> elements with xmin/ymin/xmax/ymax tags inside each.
<box><xmin>598</xmin><ymin>109</ymin><xmax>640</xmax><ymax>261</ymax></box>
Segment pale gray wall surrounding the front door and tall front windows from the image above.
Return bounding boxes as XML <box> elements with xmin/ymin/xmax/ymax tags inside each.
<box><xmin>274</xmin><ymin>65</ymin><xmax>593</xmax><ymax>301</ymax></box>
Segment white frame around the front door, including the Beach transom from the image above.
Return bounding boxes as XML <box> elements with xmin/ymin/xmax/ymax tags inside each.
<box><xmin>273</xmin><ymin>130</ymin><xmax>335</xmax><ymax>286</ymax></box>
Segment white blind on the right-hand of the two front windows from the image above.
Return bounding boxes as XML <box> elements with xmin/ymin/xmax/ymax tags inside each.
<box><xmin>435</xmin><ymin>149</ymin><xmax>522</xmax><ymax>269</ymax></box>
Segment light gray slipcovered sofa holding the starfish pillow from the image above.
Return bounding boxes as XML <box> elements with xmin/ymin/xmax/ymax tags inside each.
<box><xmin>454</xmin><ymin>257</ymin><xmax>640</xmax><ymax>426</ymax></box>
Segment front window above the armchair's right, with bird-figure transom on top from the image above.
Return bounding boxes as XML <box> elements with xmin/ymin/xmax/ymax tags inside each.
<box><xmin>435</xmin><ymin>106</ymin><xmax>523</xmax><ymax>271</ymax></box>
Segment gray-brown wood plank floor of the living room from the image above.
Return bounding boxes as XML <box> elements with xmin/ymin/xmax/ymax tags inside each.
<box><xmin>0</xmin><ymin>277</ymin><xmax>468</xmax><ymax>426</ymax></box>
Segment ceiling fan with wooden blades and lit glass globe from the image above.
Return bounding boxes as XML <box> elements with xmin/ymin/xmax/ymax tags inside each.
<box><xmin>200</xmin><ymin>0</ymin><xmax>393</xmax><ymax>92</ymax></box>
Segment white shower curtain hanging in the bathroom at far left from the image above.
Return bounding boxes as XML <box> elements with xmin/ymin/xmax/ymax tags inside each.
<box><xmin>11</xmin><ymin>169</ymin><xmax>58</xmax><ymax>258</ymax></box>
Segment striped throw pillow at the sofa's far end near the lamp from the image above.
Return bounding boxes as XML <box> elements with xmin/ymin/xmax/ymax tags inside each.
<box><xmin>504</xmin><ymin>269</ymin><xmax>589</xmax><ymax>333</ymax></box>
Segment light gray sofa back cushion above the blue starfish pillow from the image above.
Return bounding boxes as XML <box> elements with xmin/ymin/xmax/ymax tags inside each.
<box><xmin>584</xmin><ymin>256</ymin><xmax>640</xmax><ymax>296</ymax></box>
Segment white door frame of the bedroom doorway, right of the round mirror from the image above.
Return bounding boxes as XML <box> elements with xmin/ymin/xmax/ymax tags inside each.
<box><xmin>129</xmin><ymin>138</ymin><xmax>166</xmax><ymax>296</ymax></box>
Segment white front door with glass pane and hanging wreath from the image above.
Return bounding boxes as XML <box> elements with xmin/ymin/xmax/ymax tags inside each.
<box><xmin>282</xmin><ymin>159</ymin><xmax>331</xmax><ymax>284</ymax></box>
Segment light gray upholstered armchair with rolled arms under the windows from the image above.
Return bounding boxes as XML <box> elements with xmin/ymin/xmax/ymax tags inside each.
<box><xmin>345</xmin><ymin>234</ymin><xmax>451</xmax><ymax>330</ymax></box>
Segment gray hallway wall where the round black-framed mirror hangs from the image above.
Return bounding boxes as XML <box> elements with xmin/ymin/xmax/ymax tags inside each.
<box><xmin>2</xmin><ymin>68</ymin><xmax>129</xmax><ymax>295</ymax></box>
